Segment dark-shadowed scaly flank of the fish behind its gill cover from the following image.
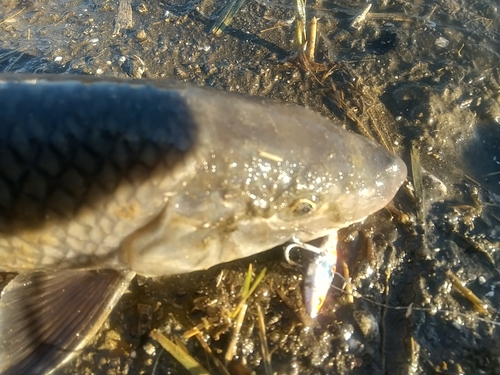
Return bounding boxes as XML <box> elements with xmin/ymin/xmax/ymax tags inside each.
<box><xmin>0</xmin><ymin>83</ymin><xmax>196</xmax><ymax>271</ymax></box>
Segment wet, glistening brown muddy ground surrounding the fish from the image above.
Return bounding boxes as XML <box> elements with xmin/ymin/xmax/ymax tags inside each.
<box><xmin>0</xmin><ymin>0</ymin><xmax>500</xmax><ymax>375</ymax></box>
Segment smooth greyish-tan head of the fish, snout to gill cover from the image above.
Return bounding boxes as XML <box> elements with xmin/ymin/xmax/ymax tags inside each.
<box><xmin>122</xmin><ymin>94</ymin><xmax>406</xmax><ymax>276</ymax></box>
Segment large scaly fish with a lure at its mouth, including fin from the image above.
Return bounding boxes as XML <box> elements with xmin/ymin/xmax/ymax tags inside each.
<box><xmin>0</xmin><ymin>74</ymin><xmax>407</xmax><ymax>375</ymax></box>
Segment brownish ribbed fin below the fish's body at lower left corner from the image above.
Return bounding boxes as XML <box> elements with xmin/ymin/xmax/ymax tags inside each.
<box><xmin>0</xmin><ymin>270</ymin><xmax>134</xmax><ymax>375</ymax></box>
